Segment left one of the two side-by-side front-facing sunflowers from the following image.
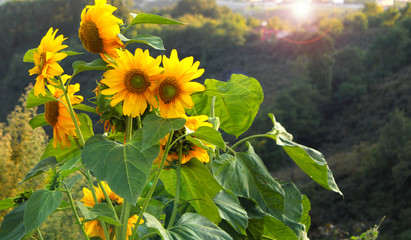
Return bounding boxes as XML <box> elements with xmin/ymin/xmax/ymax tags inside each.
<box><xmin>101</xmin><ymin>48</ymin><xmax>162</xmax><ymax>117</ymax></box>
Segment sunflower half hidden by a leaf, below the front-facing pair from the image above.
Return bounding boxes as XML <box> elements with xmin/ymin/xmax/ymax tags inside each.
<box><xmin>154</xmin><ymin>115</ymin><xmax>213</xmax><ymax>166</ymax></box>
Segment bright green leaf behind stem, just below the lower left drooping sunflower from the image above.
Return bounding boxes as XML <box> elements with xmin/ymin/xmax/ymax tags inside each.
<box><xmin>41</xmin><ymin>113</ymin><xmax>94</xmax><ymax>162</ymax></box>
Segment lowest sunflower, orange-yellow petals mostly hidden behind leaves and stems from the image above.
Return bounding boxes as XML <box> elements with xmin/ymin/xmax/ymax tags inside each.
<box><xmin>80</xmin><ymin>182</ymin><xmax>144</xmax><ymax>240</ymax></box>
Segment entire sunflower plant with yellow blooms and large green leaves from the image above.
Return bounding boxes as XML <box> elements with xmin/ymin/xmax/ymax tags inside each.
<box><xmin>0</xmin><ymin>0</ymin><xmax>342</xmax><ymax>240</ymax></box>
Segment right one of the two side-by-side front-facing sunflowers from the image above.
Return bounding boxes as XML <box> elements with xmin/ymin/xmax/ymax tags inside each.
<box><xmin>157</xmin><ymin>50</ymin><xmax>205</xmax><ymax>118</ymax></box>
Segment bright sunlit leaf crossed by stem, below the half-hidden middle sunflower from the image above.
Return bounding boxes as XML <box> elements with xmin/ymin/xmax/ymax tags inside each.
<box><xmin>160</xmin><ymin>158</ymin><xmax>222</xmax><ymax>223</ymax></box>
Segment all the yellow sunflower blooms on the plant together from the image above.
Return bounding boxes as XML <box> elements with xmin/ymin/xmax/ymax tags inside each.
<box><xmin>29</xmin><ymin>0</ymin><xmax>212</xmax><ymax>239</ymax></box>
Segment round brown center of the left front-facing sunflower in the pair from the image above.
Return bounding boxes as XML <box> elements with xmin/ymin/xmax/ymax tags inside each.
<box><xmin>124</xmin><ymin>69</ymin><xmax>151</xmax><ymax>94</ymax></box>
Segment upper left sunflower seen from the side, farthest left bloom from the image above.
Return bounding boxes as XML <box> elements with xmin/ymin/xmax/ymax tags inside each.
<box><xmin>29</xmin><ymin>28</ymin><xmax>67</xmax><ymax>96</ymax></box>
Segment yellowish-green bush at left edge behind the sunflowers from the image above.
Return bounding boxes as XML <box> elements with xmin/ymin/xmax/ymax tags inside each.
<box><xmin>0</xmin><ymin>87</ymin><xmax>48</xmax><ymax>216</ymax></box>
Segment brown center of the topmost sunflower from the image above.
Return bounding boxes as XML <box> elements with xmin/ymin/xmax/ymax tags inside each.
<box><xmin>79</xmin><ymin>20</ymin><xmax>104</xmax><ymax>53</ymax></box>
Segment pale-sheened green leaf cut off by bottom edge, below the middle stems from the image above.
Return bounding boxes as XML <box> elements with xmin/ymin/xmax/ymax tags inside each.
<box><xmin>168</xmin><ymin>213</ymin><xmax>232</xmax><ymax>240</ymax></box>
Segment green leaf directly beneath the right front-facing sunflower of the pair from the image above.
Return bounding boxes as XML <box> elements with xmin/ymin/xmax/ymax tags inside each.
<box><xmin>143</xmin><ymin>114</ymin><xmax>186</xmax><ymax>149</ymax></box>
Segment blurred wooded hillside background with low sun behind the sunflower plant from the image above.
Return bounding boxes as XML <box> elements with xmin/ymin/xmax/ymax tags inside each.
<box><xmin>0</xmin><ymin>0</ymin><xmax>411</xmax><ymax>240</ymax></box>
